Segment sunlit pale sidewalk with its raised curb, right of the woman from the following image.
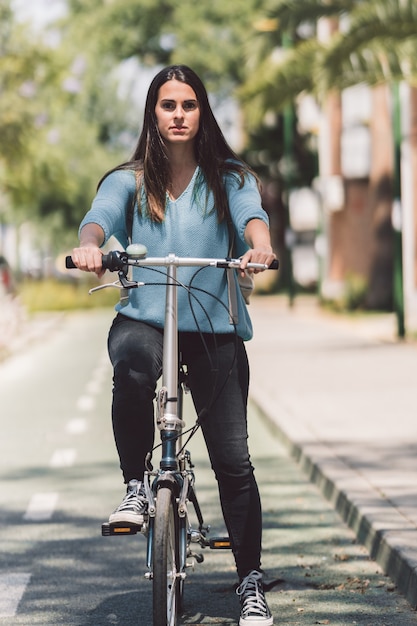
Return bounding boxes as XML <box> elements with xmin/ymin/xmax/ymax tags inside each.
<box><xmin>247</xmin><ymin>296</ymin><xmax>417</xmax><ymax>608</ymax></box>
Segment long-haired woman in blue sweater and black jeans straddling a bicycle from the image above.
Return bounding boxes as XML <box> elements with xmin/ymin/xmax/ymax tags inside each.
<box><xmin>72</xmin><ymin>65</ymin><xmax>275</xmax><ymax>626</ymax></box>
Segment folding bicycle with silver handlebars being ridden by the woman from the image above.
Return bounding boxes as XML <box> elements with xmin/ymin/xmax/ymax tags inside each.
<box><xmin>66</xmin><ymin>244</ymin><xmax>278</xmax><ymax>626</ymax></box>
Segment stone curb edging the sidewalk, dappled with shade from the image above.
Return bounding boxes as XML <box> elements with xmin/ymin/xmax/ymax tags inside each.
<box><xmin>251</xmin><ymin>389</ymin><xmax>417</xmax><ymax>609</ymax></box>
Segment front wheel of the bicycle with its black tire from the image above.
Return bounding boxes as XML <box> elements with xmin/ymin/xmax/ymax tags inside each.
<box><xmin>153</xmin><ymin>487</ymin><xmax>180</xmax><ymax>626</ymax></box>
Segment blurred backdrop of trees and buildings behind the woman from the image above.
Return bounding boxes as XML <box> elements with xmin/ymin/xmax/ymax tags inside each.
<box><xmin>0</xmin><ymin>0</ymin><xmax>417</xmax><ymax>337</ymax></box>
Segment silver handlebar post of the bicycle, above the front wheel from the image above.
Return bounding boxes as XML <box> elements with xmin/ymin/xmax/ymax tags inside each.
<box><xmin>157</xmin><ymin>255</ymin><xmax>183</xmax><ymax>470</ymax></box>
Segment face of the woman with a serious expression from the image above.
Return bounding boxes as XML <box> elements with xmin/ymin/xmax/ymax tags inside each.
<box><xmin>155</xmin><ymin>80</ymin><xmax>200</xmax><ymax>144</ymax></box>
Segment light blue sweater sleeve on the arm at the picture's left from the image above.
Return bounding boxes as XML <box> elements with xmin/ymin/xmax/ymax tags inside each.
<box><xmin>79</xmin><ymin>170</ymin><xmax>136</xmax><ymax>246</ymax></box>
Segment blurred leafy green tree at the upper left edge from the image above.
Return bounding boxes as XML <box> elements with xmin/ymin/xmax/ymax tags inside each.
<box><xmin>0</xmin><ymin>0</ymin><xmax>133</xmax><ymax>250</ymax></box>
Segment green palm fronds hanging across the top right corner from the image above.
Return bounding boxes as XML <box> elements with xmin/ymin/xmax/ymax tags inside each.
<box><xmin>239</xmin><ymin>0</ymin><xmax>417</xmax><ymax>126</ymax></box>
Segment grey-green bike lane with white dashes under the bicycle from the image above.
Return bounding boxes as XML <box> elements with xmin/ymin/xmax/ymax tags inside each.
<box><xmin>0</xmin><ymin>311</ymin><xmax>417</xmax><ymax>626</ymax></box>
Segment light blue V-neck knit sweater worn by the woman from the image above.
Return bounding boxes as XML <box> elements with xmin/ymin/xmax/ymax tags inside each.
<box><xmin>80</xmin><ymin>167</ymin><xmax>268</xmax><ymax>340</ymax></box>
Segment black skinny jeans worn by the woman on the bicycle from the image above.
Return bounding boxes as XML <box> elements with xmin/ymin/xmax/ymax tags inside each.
<box><xmin>108</xmin><ymin>314</ymin><xmax>262</xmax><ymax>577</ymax></box>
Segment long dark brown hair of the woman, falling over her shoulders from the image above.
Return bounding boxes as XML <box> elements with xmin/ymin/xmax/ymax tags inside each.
<box><xmin>99</xmin><ymin>65</ymin><xmax>257</xmax><ymax>222</ymax></box>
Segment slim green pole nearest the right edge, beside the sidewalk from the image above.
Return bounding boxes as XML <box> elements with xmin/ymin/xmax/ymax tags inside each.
<box><xmin>392</xmin><ymin>82</ymin><xmax>405</xmax><ymax>339</ymax></box>
